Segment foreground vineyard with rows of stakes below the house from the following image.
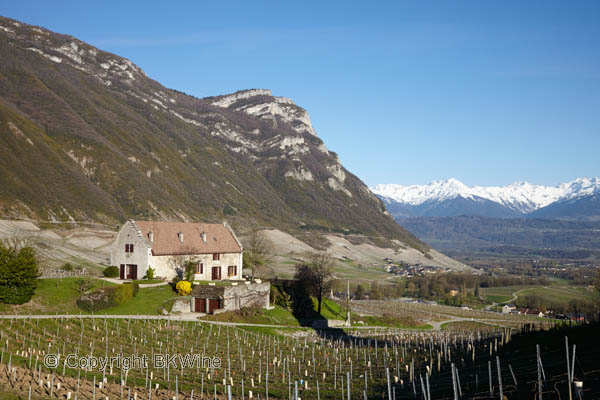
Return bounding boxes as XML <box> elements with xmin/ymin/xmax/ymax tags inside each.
<box><xmin>0</xmin><ymin>316</ymin><xmax>600</xmax><ymax>400</ymax></box>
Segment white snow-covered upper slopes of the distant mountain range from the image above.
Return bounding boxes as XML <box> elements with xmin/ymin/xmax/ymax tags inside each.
<box><xmin>371</xmin><ymin>178</ymin><xmax>600</xmax><ymax>214</ymax></box>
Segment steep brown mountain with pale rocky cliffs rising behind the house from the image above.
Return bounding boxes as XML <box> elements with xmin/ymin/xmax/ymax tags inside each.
<box><xmin>0</xmin><ymin>17</ymin><xmax>428</xmax><ymax>252</ymax></box>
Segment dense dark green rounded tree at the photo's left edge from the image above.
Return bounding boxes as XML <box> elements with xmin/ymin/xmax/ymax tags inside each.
<box><xmin>0</xmin><ymin>241</ymin><xmax>39</xmax><ymax>304</ymax></box>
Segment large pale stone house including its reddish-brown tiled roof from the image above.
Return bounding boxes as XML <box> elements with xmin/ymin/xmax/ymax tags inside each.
<box><xmin>110</xmin><ymin>220</ymin><xmax>243</xmax><ymax>281</ymax></box>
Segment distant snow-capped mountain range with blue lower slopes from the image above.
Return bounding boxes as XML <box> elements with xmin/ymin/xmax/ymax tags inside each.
<box><xmin>371</xmin><ymin>178</ymin><xmax>600</xmax><ymax>220</ymax></box>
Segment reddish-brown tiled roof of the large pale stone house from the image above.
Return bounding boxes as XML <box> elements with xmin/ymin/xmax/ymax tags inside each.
<box><xmin>135</xmin><ymin>221</ymin><xmax>242</xmax><ymax>256</ymax></box>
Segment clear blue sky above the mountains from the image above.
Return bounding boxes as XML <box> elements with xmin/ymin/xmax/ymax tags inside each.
<box><xmin>0</xmin><ymin>0</ymin><xmax>600</xmax><ymax>186</ymax></box>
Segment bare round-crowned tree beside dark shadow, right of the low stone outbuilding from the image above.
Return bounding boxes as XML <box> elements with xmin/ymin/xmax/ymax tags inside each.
<box><xmin>295</xmin><ymin>252</ymin><xmax>333</xmax><ymax>314</ymax></box>
